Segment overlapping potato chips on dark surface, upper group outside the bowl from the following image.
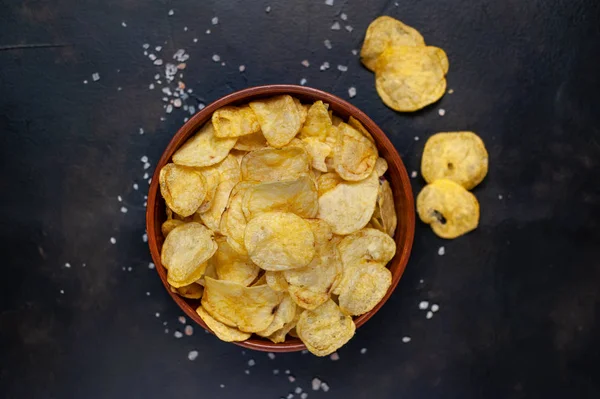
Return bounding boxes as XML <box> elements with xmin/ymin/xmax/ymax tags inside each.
<box><xmin>360</xmin><ymin>16</ymin><xmax>449</xmax><ymax>112</ymax></box>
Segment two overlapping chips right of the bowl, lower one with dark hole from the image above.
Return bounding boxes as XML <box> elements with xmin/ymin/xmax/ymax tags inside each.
<box><xmin>417</xmin><ymin>132</ymin><xmax>488</xmax><ymax>239</ymax></box>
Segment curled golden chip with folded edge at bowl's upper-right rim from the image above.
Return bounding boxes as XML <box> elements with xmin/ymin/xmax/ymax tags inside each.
<box><xmin>333</xmin><ymin>123</ymin><xmax>378</xmax><ymax>181</ymax></box>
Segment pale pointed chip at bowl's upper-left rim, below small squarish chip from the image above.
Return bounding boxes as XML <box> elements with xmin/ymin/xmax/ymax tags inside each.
<box><xmin>173</xmin><ymin>122</ymin><xmax>237</xmax><ymax>167</ymax></box>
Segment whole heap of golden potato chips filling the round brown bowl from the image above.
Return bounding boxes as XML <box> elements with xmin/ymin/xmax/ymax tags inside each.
<box><xmin>160</xmin><ymin>95</ymin><xmax>397</xmax><ymax>356</ymax></box>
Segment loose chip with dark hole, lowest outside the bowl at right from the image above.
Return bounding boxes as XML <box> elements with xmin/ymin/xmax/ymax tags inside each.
<box><xmin>417</xmin><ymin>179</ymin><xmax>479</xmax><ymax>239</ymax></box>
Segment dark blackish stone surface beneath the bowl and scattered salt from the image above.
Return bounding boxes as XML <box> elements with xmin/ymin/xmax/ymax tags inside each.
<box><xmin>0</xmin><ymin>0</ymin><xmax>600</xmax><ymax>399</ymax></box>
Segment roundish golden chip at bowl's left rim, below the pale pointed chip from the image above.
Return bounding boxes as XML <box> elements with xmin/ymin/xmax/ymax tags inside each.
<box><xmin>159</xmin><ymin>163</ymin><xmax>206</xmax><ymax>216</ymax></box>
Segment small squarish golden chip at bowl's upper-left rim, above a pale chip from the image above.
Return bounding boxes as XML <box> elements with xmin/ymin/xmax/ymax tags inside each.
<box><xmin>212</xmin><ymin>105</ymin><xmax>260</xmax><ymax>138</ymax></box>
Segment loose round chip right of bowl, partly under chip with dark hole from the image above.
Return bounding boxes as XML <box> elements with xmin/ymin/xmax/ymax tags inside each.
<box><xmin>421</xmin><ymin>132</ymin><xmax>488</xmax><ymax>190</ymax></box>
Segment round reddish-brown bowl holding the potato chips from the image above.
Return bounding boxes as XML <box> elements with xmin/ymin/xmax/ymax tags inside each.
<box><xmin>146</xmin><ymin>85</ymin><xmax>415</xmax><ymax>352</ymax></box>
